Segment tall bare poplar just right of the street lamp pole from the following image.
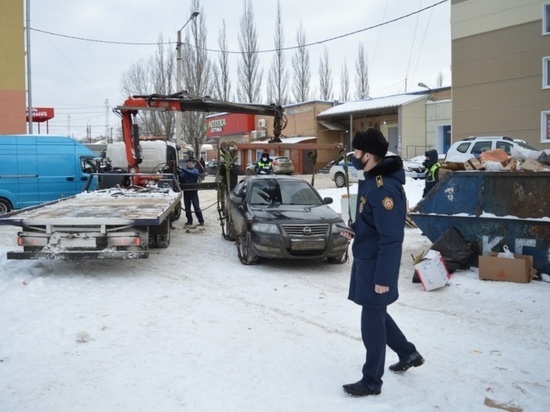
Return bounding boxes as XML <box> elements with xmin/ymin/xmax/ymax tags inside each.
<box><xmin>182</xmin><ymin>0</ymin><xmax>213</xmax><ymax>156</ymax></box>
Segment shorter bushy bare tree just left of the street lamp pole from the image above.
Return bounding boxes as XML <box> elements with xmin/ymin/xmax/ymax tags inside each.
<box><xmin>121</xmin><ymin>35</ymin><xmax>176</xmax><ymax>140</ymax></box>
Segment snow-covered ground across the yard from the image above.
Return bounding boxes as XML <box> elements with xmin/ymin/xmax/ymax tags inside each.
<box><xmin>0</xmin><ymin>175</ymin><xmax>550</xmax><ymax>412</ymax></box>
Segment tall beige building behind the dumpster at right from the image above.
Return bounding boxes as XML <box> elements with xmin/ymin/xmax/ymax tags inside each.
<box><xmin>451</xmin><ymin>0</ymin><xmax>550</xmax><ymax>149</ymax></box>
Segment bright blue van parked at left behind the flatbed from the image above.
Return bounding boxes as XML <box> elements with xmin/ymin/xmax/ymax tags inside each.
<box><xmin>0</xmin><ymin>135</ymin><xmax>97</xmax><ymax>215</ymax></box>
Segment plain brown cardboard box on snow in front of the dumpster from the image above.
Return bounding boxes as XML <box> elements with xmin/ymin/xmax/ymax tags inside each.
<box><xmin>479</xmin><ymin>252</ymin><xmax>536</xmax><ymax>283</ymax></box>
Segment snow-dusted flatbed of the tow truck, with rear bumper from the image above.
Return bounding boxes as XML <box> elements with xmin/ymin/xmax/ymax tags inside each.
<box><xmin>0</xmin><ymin>188</ymin><xmax>182</xmax><ymax>260</ymax></box>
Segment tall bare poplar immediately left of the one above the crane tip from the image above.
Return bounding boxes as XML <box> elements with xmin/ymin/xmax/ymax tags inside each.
<box><xmin>237</xmin><ymin>0</ymin><xmax>262</xmax><ymax>103</ymax></box>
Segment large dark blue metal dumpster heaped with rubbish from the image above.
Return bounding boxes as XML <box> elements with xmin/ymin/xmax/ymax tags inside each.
<box><xmin>410</xmin><ymin>171</ymin><xmax>550</xmax><ymax>274</ymax></box>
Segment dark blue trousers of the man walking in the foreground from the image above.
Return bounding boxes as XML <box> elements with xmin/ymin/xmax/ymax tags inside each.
<box><xmin>361</xmin><ymin>306</ymin><xmax>416</xmax><ymax>388</ymax></box>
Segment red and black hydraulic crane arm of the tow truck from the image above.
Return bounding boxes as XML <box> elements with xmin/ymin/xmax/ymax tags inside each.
<box><xmin>114</xmin><ymin>92</ymin><xmax>286</xmax><ymax>173</ymax></box>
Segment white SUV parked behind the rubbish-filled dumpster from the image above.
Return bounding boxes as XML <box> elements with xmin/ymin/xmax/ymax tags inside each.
<box><xmin>445</xmin><ymin>136</ymin><xmax>537</xmax><ymax>162</ymax></box>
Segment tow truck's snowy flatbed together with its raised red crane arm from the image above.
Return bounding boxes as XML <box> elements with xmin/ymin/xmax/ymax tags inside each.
<box><xmin>0</xmin><ymin>92</ymin><xmax>285</xmax><ymax>259</ymax></box>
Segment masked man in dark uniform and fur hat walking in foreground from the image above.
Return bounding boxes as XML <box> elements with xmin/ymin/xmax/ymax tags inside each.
<box><xmin>340</xmin><ymin>129</ymin><xmax>424</xmax><ymax>396</ymax></box>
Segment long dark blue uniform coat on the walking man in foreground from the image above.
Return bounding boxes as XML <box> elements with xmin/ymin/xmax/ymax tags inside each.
<box><xmin>348</xmin><ymin>156</ymin><xmax>407</xmax><ymax>308</ymax></box>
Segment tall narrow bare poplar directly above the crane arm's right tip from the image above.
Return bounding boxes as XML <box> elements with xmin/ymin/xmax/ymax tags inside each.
<box><xmin>267</xmin><ymin>0</ymin><xmax>288</xmax><ymax>105</ymax></box>
